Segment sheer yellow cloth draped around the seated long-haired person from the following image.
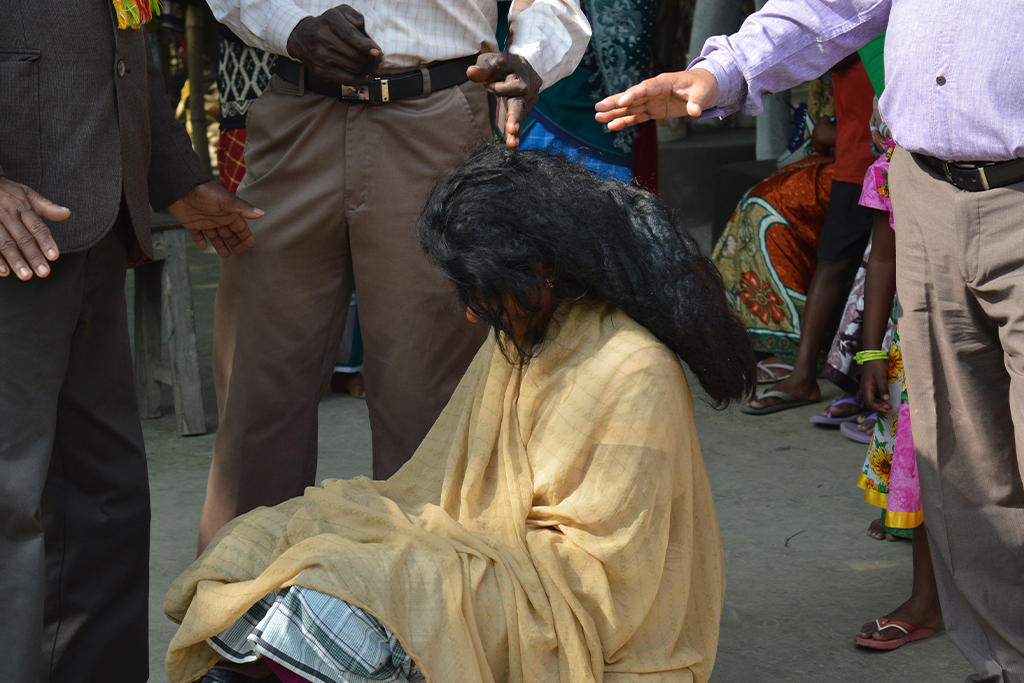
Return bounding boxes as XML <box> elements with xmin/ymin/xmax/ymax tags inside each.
<box><xmin>165</xmin><ymin>304</ymin><xmax>725</xmax><ymax>683</ymax></box>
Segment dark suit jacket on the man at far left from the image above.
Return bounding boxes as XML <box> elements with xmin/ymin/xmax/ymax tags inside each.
<box><xmin>0</xmin><ymin>0</ymin><xmax>210</xmax><ymax>256</ymax></box>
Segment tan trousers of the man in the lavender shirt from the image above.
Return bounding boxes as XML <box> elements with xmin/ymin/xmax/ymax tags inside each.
<box><xmin>890</xmin><ymin>150</ymin><xmax>1024</xmax><ymax>681</ymax></box>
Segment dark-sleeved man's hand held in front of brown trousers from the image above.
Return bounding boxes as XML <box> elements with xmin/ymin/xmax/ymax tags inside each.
<box><xmin>168</xmin><ymin>180</ymin><xmax>263</xmax><ymax>258</ymax></box>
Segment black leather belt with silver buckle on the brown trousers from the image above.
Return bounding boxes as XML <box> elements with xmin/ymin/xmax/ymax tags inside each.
<box><xmin>270</xmin><ymin>54</ymin><xmax>476</xmax><ymax>104</ymax></box>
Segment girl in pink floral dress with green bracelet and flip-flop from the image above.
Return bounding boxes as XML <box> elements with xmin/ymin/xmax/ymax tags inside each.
<box><xmin>855</xmin><ymin>140</ymin><xmax>942</xmax><ymax>649</ymax></box>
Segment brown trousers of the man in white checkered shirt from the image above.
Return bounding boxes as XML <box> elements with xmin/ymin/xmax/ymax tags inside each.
<box><xmin>200</xmin><ymin>72</ymin><xmax>489</xmax><ymax>549</ymax></box>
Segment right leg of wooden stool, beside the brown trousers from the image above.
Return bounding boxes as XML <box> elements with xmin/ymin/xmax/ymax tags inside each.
<box><xmin>162</xmin><ymin>230</ymin><xmax>207</xmax><ymax>435</ymax></box>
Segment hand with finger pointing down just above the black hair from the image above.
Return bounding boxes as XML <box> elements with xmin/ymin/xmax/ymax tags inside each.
<box><xmin>466</xmin><ymin>52</ymin><xmax>544</xmax><ymax>147</ymax></box>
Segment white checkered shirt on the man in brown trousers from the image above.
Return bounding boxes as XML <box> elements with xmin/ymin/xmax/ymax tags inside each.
<box><xmin>208</xmin><ymin>0</ymin><xmax>590</xmax><ymax>87</ymax></box>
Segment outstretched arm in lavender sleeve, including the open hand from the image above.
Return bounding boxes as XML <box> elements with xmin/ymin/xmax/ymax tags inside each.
<box><xmin>596</xmin><ymin>0</ymin><xmax>892</xmax><ymax>130</ymax></box>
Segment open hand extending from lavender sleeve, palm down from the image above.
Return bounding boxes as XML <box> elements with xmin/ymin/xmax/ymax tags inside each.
<box><xmin>594</xmin><ymin>69</ymin><xmax>718</xmax><ymax>130</ymax></box>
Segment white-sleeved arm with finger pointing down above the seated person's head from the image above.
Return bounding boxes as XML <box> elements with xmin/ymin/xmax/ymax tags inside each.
<box><xmin>466</xmin><ymin>0</ymin><xmax>591</xmax><ymax>147</ymax></box>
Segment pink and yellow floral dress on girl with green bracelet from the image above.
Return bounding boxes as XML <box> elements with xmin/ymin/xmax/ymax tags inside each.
<box><xmin>857</xmin><ymin>141</ymin><xmax>924</xmax><ymax>538</ymax></box>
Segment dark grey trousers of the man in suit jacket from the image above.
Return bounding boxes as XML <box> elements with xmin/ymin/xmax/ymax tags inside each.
<box><xmin>0</xmin><ymin>225</ymin><xmax>150</xmax><ymax>683</ymax></box>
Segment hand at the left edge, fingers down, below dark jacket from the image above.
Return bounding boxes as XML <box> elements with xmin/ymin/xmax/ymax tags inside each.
<box><xmin>0</xmin><ymin>177</ymin><xmax>71</xmax><ymax>280</ymax></box>
